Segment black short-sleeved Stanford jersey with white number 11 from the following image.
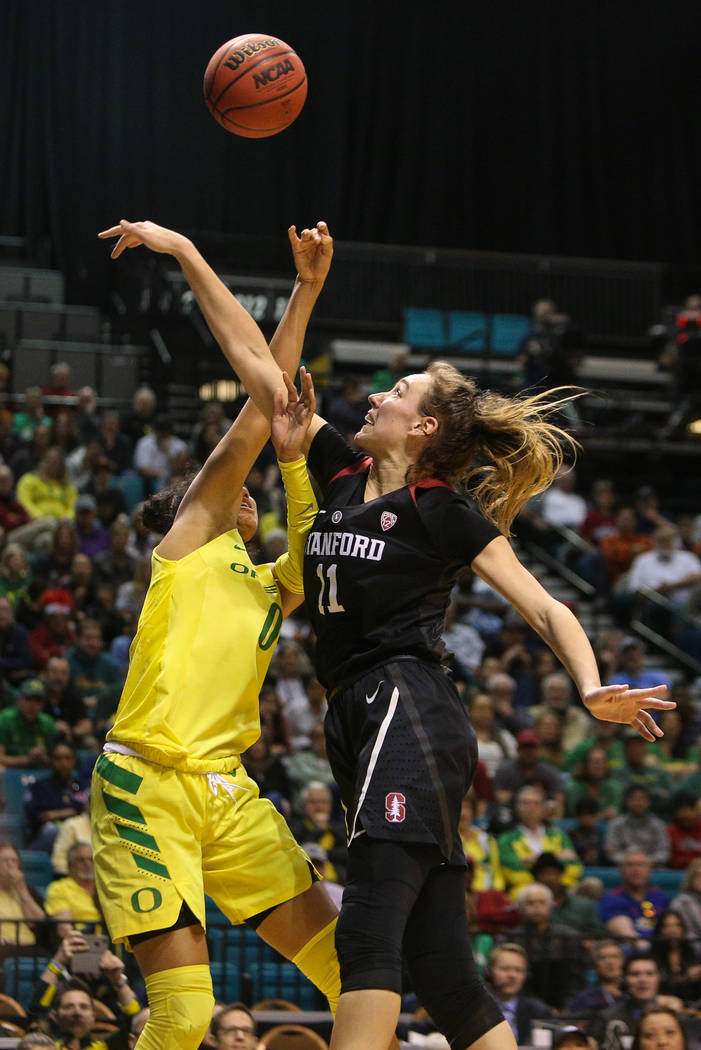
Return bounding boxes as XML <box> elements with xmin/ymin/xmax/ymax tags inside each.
<box><xmin>304</xmin><ymin>424</ymin><xmax>501</xmax><ymax>689</ymax></box>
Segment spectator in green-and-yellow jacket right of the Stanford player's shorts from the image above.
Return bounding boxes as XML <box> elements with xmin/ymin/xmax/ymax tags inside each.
<box><xmin>497</xmin><ymin>785</ymin><xmax>581</xmax><ymax>896</ymax></box>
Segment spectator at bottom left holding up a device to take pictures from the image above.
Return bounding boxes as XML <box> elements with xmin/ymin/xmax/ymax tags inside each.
<box><xmin>27</xmin><ymin>931</ymin><xmax>141</xmax><ymax>1050</ymax></box>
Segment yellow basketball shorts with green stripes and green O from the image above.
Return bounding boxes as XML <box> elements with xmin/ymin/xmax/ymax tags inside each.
<box><xmin>90</xmin><ymin>753</ymin><xmax>315</xmax><ymax>943</ymax></box>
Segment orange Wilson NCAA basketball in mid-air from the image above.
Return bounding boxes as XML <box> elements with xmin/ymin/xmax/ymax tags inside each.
<box><xmin>205</xmin><ymin>33</ymin><xmax>306</xmax><ymax>139</ymax></box>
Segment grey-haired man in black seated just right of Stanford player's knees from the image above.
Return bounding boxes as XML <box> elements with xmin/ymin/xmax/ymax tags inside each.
<box><xmin>509</xmin><ymin>882</ymin><xmax>587</xmax><ymax>1010</ymax></box>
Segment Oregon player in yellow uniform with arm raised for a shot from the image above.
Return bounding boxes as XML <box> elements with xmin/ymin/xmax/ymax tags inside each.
<box><xmin>91</xmin><ymin>222</ymin><xmax>339</xmax><ymax>1050</ymax></box>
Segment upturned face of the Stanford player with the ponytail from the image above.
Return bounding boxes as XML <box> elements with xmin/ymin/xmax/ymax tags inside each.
<box><xmin>356</xmin><ymin>373</ymin><xmax>431</xmax><ymax>454</ymax></box>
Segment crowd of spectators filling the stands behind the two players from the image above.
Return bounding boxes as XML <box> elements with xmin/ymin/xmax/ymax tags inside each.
<box><xmin>0</xmin><ymin>354</ymin><xmax>701</xmax><ymax>1050</ymax></box>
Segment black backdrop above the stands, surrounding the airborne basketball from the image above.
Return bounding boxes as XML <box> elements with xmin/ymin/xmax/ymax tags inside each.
<box><xmin>0</xmin><ymin>0</ymin><xmax>701</xmax><ymax>301</ymax></box>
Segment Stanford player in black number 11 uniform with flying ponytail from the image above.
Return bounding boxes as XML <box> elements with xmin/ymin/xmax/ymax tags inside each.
<box><xmin>112</xmin><ymin>225</ymin><xmax>675</xmax><ymax>1050</ymax></box>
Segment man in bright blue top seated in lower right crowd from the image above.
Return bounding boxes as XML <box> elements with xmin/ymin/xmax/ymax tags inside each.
<box><xmin>599</xmin><ymin>849</ymin><xmax>670</xmax><ymax>942</ymax></box>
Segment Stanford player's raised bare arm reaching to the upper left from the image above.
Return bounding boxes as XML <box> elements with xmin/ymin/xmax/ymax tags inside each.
<box><xmin>98</xmin><ymin>218</ymin><xmax>286</xmax><ymax>419</ymax></box>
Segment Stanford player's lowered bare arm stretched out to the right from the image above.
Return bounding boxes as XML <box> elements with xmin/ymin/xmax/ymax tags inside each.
<box><xmin>472</xmin><ymin>537</ymin><xmax>677</xmax><ymax>740</ymax></box>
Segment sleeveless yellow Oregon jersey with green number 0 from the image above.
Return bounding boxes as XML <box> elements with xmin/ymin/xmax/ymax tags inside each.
<box><xmin>107</xmin><ymin>529</ymin><xmax>282</xmax><ymax>773</ymax></box>
